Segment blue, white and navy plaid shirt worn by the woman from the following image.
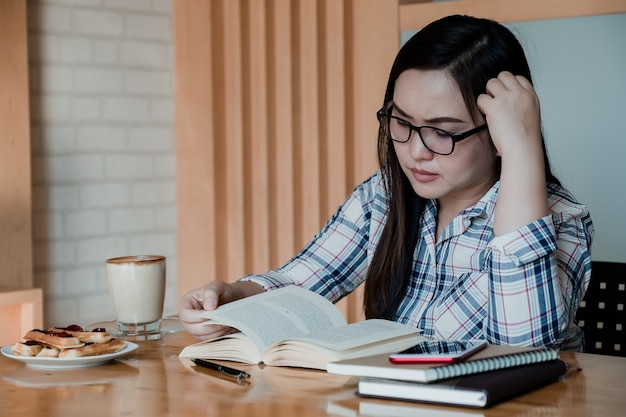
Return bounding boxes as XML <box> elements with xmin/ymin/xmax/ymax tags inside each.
<box><xmin>243</xmin><ymin>173</ymin><xmax>593</xmax><ymax>350</ymax></box>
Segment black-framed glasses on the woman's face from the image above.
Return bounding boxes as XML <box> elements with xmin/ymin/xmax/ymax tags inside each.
<box><xmin>376</xmin><ymin>102</ymin><xmax>487</xmax><ymax>155</ymax></box>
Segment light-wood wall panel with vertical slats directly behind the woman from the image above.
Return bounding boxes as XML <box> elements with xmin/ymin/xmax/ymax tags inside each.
<box><xmin>174</xmin><ymin>0</ymin><xmax>398</xmax><ymax>320</ymax></box>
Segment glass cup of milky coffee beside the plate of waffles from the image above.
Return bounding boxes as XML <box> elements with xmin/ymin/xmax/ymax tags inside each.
<box><xmin>106</xmin><ymin>255</ymin><xmax>165</xmax><ymax>340</ymax></box>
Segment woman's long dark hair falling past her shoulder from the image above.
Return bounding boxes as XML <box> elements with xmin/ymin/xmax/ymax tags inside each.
<box><xmin>364</xmin><ymin>15</ymin><xmax>559</xmax><ymax>320</ymax></box>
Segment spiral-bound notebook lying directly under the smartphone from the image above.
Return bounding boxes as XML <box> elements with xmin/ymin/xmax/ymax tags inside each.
<box><xmin>327</xmin><ymin>345</ymin><xmax>559</xmax><ymax>383</ymax></box>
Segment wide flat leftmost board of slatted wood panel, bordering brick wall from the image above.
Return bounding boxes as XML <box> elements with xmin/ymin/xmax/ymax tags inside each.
<box><xmin>173</xmin><ymin>1</ymin><xmax>217</xmax><ymax>295</ymax></box>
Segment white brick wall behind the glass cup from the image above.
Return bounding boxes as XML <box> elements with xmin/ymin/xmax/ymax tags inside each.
<box><xmin>28</xmin><ymin>0</ymin><xmax>177</xmax><ymax>326</ymax></box>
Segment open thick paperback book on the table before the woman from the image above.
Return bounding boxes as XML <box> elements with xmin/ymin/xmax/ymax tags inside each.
<box><xmin>179</xmin><ymin>286</ymin><xmax>425</xmax><ymax>370</ymax></box>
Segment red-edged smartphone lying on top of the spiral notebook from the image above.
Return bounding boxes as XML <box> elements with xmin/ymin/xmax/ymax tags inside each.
<box><xmin>389</xmin><ymin>340</ymin><xmax>488</xmax><ymax>364</ymax></box>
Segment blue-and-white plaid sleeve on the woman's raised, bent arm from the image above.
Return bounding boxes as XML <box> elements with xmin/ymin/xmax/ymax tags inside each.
<box><xmin>485</xmin><ymin>192</ymin><xmax>593</xmax><ymax>350</ymax></box>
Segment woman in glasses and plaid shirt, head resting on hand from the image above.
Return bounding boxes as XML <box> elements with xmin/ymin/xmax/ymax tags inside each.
<box><xmin>179</xmin><ymin>16</ymin><xmax>593</xmax><ymax>350</ymax></box>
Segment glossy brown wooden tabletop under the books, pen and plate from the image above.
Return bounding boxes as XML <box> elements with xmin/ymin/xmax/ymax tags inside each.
<box><xmin>0</xmin><ymin>332</ymin><xmax>626</xmax><ymax>417</ymax></box>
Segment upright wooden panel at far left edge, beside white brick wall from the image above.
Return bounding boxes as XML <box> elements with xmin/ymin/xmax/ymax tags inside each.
<box><xmin>0</xmin><ymin>0</ymin><xmax>33</xmax><ymax>288</ymax></box>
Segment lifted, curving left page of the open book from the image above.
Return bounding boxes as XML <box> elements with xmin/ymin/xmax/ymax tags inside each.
<box><xmin>203</xmin><ymin>286</ymin><xmax>346</xmax><ymax>352</ymax></box>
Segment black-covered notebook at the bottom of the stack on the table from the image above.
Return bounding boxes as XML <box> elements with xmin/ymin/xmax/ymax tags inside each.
<box><xmin>357</xmin><ymin>359</ymin><xmax>567</xmax><ymax>408</ymax></box>
